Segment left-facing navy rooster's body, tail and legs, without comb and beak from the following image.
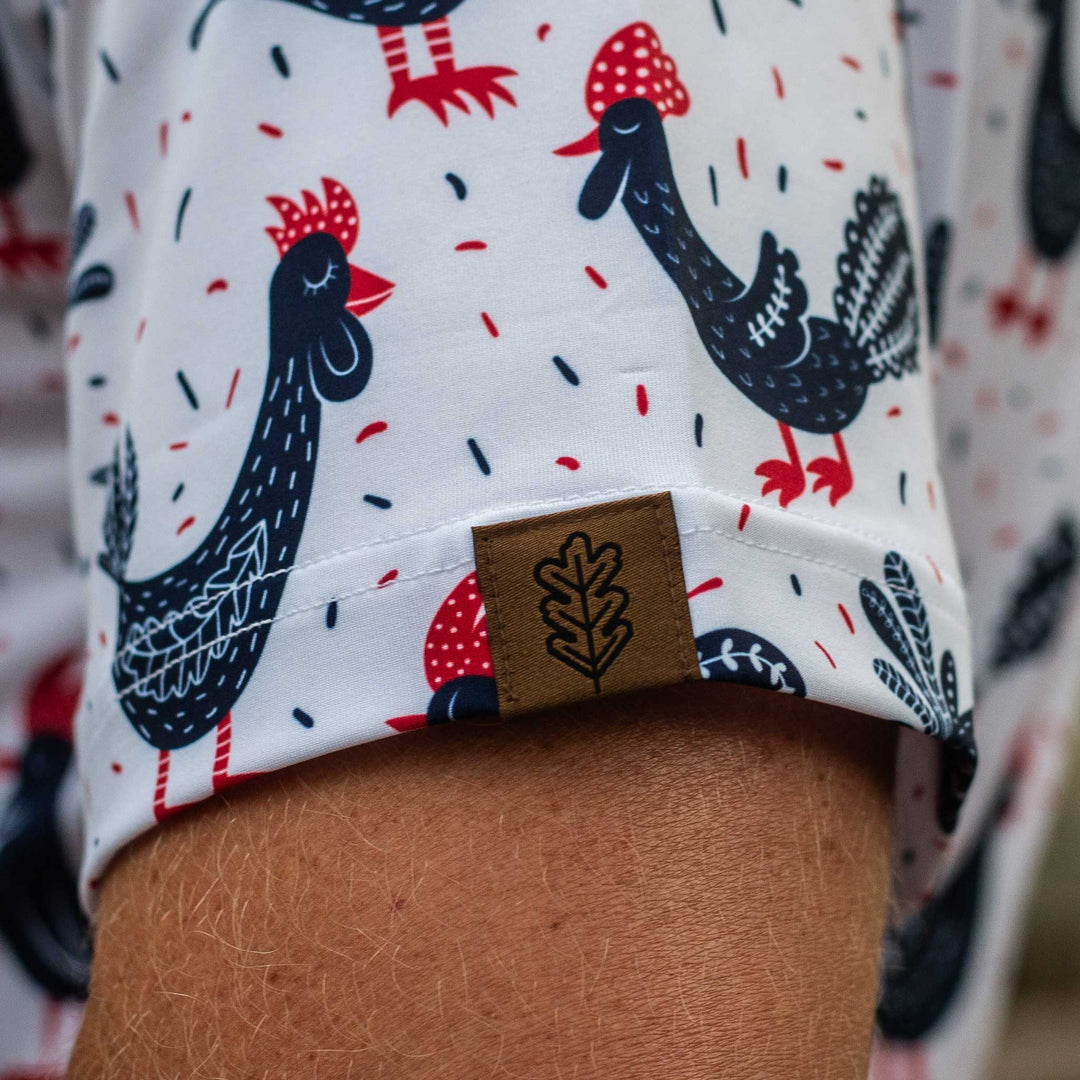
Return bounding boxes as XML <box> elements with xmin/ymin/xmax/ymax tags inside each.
<box><xmin>579</xmin><ymin>98</ymin><xmax>919</xmax><ymax>507</ymax></box>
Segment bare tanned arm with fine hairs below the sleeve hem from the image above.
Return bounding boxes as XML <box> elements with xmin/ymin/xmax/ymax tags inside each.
<box><xmin>69</xmin><ymin>684</ymin><xmax>893</xmax><ymax>1080</ymax></box>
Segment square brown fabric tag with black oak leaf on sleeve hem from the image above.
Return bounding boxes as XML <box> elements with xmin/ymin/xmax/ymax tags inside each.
<box><xmin>473</xmin><ymin>491</ymin><xmax>701</xmax><ymax>716</ymax></box>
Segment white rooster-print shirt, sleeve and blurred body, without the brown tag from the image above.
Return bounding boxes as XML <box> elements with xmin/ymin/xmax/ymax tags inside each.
<box><xmin>0</xmin><ymin>0</ymin><xmax>1080</xmax><ymax>1080</ymax></box>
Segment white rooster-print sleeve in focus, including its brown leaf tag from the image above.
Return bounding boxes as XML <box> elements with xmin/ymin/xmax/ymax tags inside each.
<box><xmin>52</xmin><ymin>0</ymin><xmax>974</xmax><ymax>920</ymax></box>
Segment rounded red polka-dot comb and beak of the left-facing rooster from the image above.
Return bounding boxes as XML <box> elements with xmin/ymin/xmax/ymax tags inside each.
<box><xmin>555</xmin><ymin>23</ymin><xmax>690</xmax><ymax>158</ymax></box>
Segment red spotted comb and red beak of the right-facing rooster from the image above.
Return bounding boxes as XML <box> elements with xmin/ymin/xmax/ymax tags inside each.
<box><xmin>267</xmin><ymin>176</ymin><xmax>394</xmax><ymax>318</ymax></box>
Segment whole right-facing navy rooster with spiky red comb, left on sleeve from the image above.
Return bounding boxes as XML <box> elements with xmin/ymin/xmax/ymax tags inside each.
<box><xmin>98</xmin><ymin>178</ymin><xmax>393</xmax><ymax>820</ymax></box>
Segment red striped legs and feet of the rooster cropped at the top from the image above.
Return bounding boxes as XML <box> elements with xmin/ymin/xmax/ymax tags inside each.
<box><xmin>379</xmin><ymin>18</ymin><xmax>517</xmax><ymax>125</ymax></box>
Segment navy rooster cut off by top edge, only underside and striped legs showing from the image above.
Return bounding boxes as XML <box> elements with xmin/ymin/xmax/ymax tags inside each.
<box><xmin>191</xmin><ymin>0</ymin><xmax>517</xmax><ymax>124</ymax></box>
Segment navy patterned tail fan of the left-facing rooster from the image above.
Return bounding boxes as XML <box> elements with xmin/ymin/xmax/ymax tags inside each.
<box><xmin>833</xmin><ymin>176</ymin><xmax>919</xmax><ymax>382</ymax></box>
